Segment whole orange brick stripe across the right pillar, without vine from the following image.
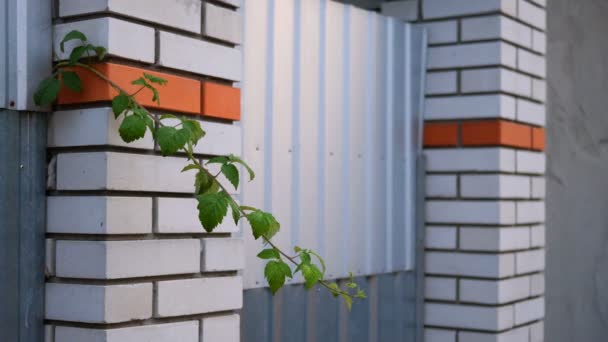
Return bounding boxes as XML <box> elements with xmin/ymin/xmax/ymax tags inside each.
<box><xmin>424</xmin><ymin>119</ymin><xmax>545</xmax><ymax>151</ymax></box>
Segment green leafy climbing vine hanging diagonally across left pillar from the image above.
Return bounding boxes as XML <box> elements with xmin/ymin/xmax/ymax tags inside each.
<box><xmin>34</xmin><ymin>31</ymin><xmax>366</xmax><ymax>310</ymax></box>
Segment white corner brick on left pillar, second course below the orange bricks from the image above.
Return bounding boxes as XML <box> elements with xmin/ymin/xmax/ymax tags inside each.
<box><xmin>57</xmin><ymin>152</ymin><xmax>194</xmax><ymax>193</ymax></box>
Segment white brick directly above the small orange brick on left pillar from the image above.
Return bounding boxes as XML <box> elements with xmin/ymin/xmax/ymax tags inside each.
<box><xmin>158</xmin><ymin>31</ymin><xmax>242</xmax><ymax>81</ymax></box>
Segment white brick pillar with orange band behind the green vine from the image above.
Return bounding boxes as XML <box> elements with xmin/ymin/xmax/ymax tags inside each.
<box><xmin>45</xmin><ymin>0</ymin><xmax>244</xmax><ymax>342</ymax></box>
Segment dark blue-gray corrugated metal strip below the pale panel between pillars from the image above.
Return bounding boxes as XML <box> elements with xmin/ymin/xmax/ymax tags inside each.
<box><xmin>241</xmin><ymin>272</ymin><xmax>417</xmax><ymax>342</ymax></box>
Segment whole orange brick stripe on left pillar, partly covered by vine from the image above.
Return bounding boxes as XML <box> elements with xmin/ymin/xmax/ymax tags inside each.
<box><xmin>57</xmin><ymin>63</ymin><xmax>241</xmax><ymax>120</ymax></box>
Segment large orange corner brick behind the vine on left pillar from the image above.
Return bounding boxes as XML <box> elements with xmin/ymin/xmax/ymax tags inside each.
<box><xmin>57</xmin><ymin>63</ymin><xmax>201</xmax><ymax>114</ymax></box>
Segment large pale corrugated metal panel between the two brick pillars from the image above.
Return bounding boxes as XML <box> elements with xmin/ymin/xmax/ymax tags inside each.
<box><xmin>243</xmin><ymin>0</ymin><xmax>423</xmax><ymax>288</ymax></box>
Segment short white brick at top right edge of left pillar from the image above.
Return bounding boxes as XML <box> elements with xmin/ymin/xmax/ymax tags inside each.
<box><xmin>203</xmin><ymin>3</ymin><xmax>243</xmax><ymax>44</ymax></box>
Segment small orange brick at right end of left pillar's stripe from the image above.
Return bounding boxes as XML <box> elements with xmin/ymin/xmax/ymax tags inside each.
<box><xmin>200</xmin><ymin>82</ymin><xmax>241</xmax><ymax>121</ymax></box>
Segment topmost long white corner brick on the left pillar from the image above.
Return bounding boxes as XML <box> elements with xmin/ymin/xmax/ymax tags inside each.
<box><xmin>59</xmin><ymin>0</ymin><xmax>201</xmax><ymax>33</ymax></box>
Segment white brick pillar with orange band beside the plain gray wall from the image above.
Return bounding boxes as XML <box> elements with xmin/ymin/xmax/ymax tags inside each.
<box><xmin>421</xmin><ymin>0</ymin><xmax>546</xmax><ymax>342</ymax></box>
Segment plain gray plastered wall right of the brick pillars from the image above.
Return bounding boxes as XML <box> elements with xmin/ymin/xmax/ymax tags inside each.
<box><xmin>545</xmin><ymin>0</ymin><xmax>608</xmax><ymax>342</ymax></box>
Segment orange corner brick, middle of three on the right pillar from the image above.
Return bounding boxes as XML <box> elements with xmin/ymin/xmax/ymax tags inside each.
<box><xmin>462</xmin><ymin>120</ymin><xmax>532</xmax><ymax>148</ymax></box>
